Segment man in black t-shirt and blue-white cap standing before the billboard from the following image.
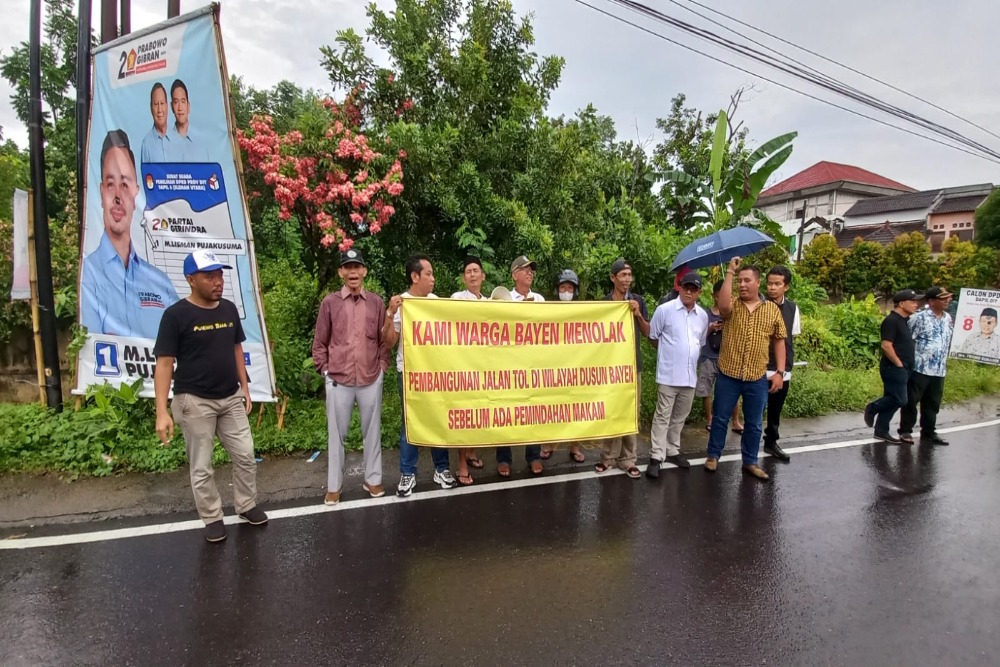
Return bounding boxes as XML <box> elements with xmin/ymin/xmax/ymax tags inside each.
<box><xmin>153</xmin><ymin>250</ymin><xmax>267</xmax><ymax>542</ymax></box>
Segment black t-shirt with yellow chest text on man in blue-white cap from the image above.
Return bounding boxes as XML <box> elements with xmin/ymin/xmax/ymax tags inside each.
<box><xmin>153</xmin><ymin>299</ymin><xmax>246</xmax><ymax>399</ymax></box>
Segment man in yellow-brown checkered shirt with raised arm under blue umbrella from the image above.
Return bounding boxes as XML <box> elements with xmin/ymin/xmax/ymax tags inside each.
<box><xmin>705</xmin><ymin>257</ymin><xmax>788</xmax><ymax>481</ymax></box>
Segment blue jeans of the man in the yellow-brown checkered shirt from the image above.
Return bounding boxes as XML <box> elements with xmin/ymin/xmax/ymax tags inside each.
<box><xmin>708</xmin><ymin>371</ymin><xmax>770</xmax><ymax>465</ymax></box>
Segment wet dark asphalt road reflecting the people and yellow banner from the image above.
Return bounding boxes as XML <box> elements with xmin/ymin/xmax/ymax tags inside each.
<box><xmin>0</xmin><ymin>426</ymin><xmax>1000</xmax><ymax>665</ymax></box>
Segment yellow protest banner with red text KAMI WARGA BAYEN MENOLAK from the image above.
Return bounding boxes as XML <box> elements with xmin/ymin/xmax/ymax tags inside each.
<box><xmin>400</xmin><ymin>298</ymin><xmax>639</xmax><ymax>447</ymax></box>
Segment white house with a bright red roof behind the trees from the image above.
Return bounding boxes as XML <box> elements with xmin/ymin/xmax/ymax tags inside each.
<box><xmin>757</xmin><ymin>161</ymin><xmax>913</xmax><ymax>257</ymax></box>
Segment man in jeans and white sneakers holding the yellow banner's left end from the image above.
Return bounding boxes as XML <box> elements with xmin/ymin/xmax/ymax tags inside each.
<box><xmin>385</xmin><ymin>255</ymin><xmax>456</xmax><ymax>498</ymax></box>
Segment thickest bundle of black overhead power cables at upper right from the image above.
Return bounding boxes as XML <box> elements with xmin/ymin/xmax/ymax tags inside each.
<box><xmin>607</xmin><ymin>0</ymin><xmax>1000</xmax><ymax>159</ymax></box>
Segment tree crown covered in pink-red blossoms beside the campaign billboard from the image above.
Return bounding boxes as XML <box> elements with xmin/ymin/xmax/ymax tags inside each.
<box><xmin>239</xmin><ymin>91</ymin><xmax>406</xmax><ymax>290</ymax></box>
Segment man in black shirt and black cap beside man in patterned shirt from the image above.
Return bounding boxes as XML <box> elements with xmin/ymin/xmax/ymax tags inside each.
<box><xmin>865</xmin><ymin>289</ymin><xmax>923</xmax><ymax>445</ymax></box>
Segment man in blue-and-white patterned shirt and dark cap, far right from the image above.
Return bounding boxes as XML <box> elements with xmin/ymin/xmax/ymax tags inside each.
<box><xmin>899</xmin><ymin>287</ymin><xmax>954</xmax><ymax>445</ymax></box>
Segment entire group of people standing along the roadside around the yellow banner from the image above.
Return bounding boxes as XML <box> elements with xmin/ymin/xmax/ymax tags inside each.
<box><xmin>155</xmin><ymin>249</ymin><xmax>968</xmax><ymax>542</ymax></box>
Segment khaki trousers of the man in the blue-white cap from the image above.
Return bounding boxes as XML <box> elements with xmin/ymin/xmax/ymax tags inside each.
<box><xmin>170</xmin><ymin>390</ymin><xmax>257</xmax><ymax>524</ymax></box>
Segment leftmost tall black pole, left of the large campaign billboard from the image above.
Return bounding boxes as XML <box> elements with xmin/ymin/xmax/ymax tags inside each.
<box><xmin>28</xmin><ymin>0</ymin><xmax>62</xmax><ymax>411</ymax></box>
